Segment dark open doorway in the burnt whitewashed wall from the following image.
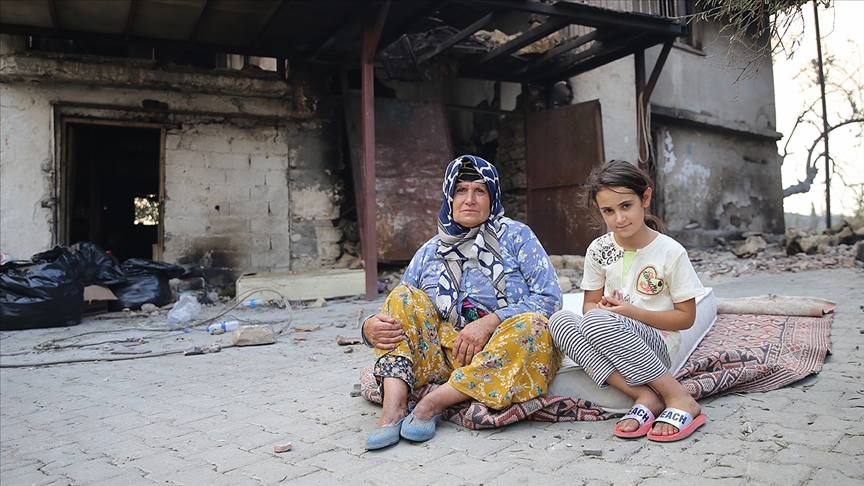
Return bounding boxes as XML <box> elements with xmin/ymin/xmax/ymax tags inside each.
<box><xmin>63</xmin><ymin>120</ymin><xmax>163</xmax><ymax>262</ymax></box>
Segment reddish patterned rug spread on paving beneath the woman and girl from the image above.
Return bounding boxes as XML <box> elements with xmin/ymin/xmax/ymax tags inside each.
<box><xmin>360</xmin><ymin>313</ymin><xmax>834</xmax><ymax>429</ymax></box>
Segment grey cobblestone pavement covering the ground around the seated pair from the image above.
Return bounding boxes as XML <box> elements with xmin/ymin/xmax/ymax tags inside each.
<box><xmin>0</xmin><ymin>268</ymin><xmax>864</xmax><ymax>486</ymax></box>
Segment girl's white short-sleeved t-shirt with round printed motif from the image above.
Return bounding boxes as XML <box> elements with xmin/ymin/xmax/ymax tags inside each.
<box><xmin>582</xmin><ymin>233</ymin><xmax>705</xmax><ymax>359</ymax></box>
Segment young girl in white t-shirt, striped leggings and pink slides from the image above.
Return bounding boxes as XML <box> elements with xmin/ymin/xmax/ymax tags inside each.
<box><xmin>549</xmin><ymin>160</ymin><xmax>705</xmax><ymax>442</ymax></box>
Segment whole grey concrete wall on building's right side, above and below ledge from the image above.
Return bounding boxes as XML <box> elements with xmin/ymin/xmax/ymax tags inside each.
<box><xmin>571</xmin><ymin>16</ymin><xmax>784</xmax><ymax>246</ymax></box>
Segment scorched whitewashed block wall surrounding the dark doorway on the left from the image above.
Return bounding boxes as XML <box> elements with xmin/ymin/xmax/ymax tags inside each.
<box><xmin>0</xmin><ymin>36</ymin><xmax>344</xmax><ymax>285</ymax></box>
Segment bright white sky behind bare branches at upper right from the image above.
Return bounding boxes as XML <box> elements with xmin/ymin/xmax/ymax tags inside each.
<box><xmin>774</xmin><ymin>0</ymin><xmax>864</xmax><ymax>219</ymax></box>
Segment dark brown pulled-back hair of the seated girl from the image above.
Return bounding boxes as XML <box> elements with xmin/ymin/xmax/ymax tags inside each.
<box><xmin>581</xmin><ymin>160</ymin><xmax>666</xmax><ymax>233</ymax></box>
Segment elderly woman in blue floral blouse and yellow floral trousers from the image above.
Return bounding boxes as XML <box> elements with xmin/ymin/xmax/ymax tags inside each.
<box><xmin>361</xmin><ymin>155</ymin><xmax>561</xmax><ymax>450</ymax></box>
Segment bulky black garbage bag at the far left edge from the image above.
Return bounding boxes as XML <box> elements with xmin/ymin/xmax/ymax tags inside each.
<box><xmin>0</xmin><ymin>246</ymin><xmax>84</xmax><ymax>331</ymax></box>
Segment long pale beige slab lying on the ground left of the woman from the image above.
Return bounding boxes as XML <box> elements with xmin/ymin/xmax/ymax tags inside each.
<box><xmin>236</xmin><ymin>269</ymin><xmax>366</xmax><ymax>301</ymax></box>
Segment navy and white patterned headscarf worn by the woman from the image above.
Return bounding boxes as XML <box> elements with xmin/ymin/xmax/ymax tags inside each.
<box><xmin>436</xmin><ymin>155</ymin><xmax>507</xmax><ymax>328</ymax></box>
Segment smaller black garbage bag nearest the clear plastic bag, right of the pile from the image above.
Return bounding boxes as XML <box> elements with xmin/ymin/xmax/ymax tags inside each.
<box><xmin>108</xmin><ymin>258</ymin><xmax>186</xmax><ymax>311</ymax></box>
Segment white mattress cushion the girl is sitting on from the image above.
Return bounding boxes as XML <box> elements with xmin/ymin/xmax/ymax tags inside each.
<box><xmin>547</xmin><ymin>287</ymin><xmax>717</xmax><ymax>412</ymax></box>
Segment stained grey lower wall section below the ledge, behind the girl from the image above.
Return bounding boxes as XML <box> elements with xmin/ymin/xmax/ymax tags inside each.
<box><xmin>654</xmin><ymin>125</ymin><xmax>784</xmax><ymax>247</ymax></box>
